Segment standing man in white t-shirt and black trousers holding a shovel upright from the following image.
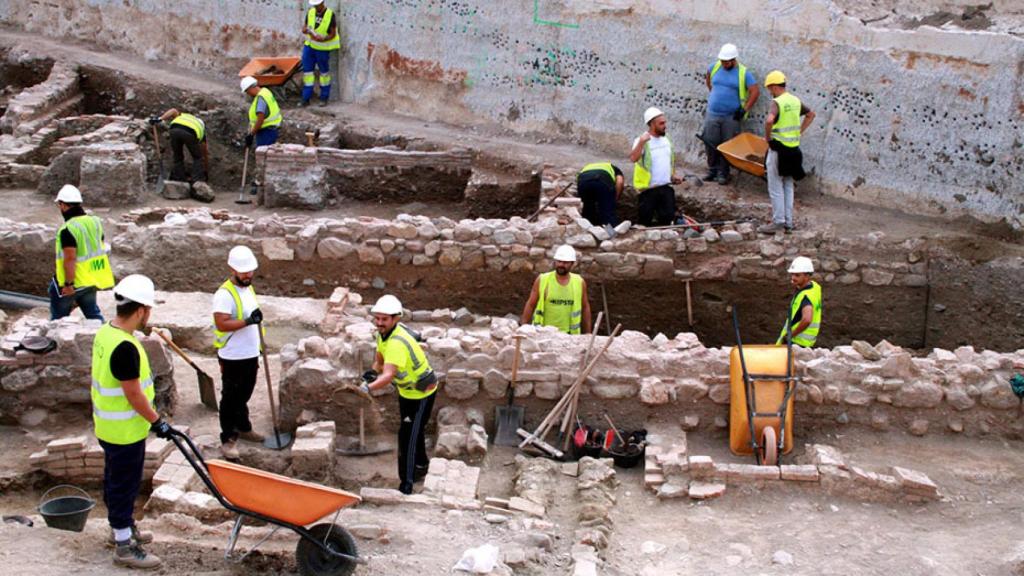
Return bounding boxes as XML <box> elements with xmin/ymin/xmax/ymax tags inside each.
<box><xmin>213</xmin><ymin>246</ymin><xmax>265</xmax><ymax>460</ymax></box>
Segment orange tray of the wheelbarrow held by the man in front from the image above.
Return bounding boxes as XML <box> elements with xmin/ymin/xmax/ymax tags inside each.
<box><xmin>206</xmin><ymin>460</ymin><xmax>361</xmax><ymax>526</ymax></box>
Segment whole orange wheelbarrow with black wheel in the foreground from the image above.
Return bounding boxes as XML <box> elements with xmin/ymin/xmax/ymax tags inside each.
<box><xmin>171</xmin><ymin>429</ymin><xmax>367</xmax><ymax>576</ymax></box>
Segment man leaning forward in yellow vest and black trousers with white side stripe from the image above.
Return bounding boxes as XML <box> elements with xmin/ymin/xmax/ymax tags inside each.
<box><xmin>359</xmin><ymin>294</ymin><xmax>437</xmax><ymax>494</ymax></box>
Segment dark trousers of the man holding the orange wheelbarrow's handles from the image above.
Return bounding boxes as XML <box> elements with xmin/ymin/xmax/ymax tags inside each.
<box><xmin>99</xmin><ymin>439</ymin><xmax>145</xmax><ymax>530</ymax></box>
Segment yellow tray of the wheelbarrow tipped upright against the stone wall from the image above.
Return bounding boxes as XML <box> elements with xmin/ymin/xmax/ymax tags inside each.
<box><xmin>729</xmin><ymin>344</ymin><xmax>794</xmax><ymax>456</ymax></box>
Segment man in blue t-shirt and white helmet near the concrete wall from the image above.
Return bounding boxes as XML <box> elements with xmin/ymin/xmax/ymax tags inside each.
<box><xmin>703</xmin><ymin>44</ymin><xmax>761</xmax><ymax>184</ymax></box>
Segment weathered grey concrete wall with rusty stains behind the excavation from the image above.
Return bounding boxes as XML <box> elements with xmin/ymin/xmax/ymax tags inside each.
<box><xmin>0</xmin><ymin>0</ymin><xmax>1024</xmax><ymax>227</ymax></box>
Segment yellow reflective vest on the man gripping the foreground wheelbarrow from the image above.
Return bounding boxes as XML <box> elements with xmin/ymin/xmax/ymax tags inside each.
<box><xmin>90</xmin><ymin>323</ymin><xmax>156</xmax><ymax>445</ymax></box>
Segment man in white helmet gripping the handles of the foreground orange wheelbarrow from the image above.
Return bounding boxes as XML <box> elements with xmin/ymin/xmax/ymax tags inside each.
<box><xmin>90</xmin><ymin>274</ymin><xmax>171</xmax><ymax>569</ymax></box>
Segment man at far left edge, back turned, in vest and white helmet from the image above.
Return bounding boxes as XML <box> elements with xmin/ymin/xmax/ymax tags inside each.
<box><xmin>46</xmin><ymin>184</ymin><xmax>114</xmax><ymax>321</ymax></box>
